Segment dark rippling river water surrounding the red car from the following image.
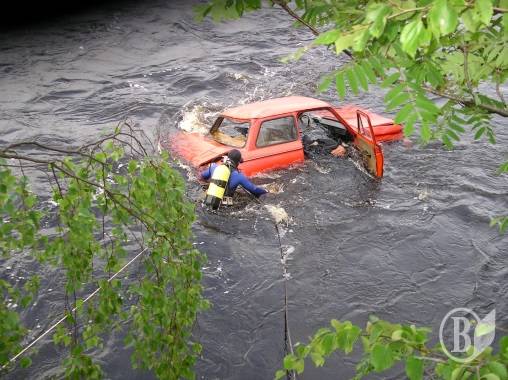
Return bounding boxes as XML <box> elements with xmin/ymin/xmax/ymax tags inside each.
<box><xmin>0</xmin><ymin>0</ymin><xmax>508</xmax><ymax>379</ymax></box>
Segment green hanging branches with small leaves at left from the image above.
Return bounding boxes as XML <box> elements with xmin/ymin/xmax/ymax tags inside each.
<box><xmin>0</xmin><ymin>125</ymin><xmax>207</xmax><ymax>379</ymax></box>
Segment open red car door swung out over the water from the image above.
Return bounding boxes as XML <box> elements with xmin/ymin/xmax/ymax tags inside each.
<box><xmin>353</xmin><ymin>110</ymin><xmax>384</xmax><ymax>178</ymax></box>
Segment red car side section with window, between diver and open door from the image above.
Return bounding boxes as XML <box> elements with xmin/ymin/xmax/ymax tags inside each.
<box><xmin>241</xmin><ymin>114</ymin><xmax>304</xmax><ymax>174</ymax></box>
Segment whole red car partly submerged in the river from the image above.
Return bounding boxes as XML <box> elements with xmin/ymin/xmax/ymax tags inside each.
<box><xmin>168</xmin><ymin>96</ymin><xmax>403</xmax><ymax>177</ymax></box>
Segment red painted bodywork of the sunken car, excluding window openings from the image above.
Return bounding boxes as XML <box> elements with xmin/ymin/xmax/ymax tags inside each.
<box><xmin>168</xmin><ymin>96</ymin><xmax>402</xmax><ymax>177</ymax></box>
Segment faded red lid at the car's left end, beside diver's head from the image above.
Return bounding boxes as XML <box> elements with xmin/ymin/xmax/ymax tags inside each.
<box><xmin>169</xmin><ymin>132</ymin><xmax>232</xmax><ymax>167</ymax></box>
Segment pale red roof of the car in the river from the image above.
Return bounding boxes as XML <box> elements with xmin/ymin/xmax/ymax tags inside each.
<box><xmin>222</xmin><ymin>96</ymin><xmax>331</xmax><ymax>119</ymax></box>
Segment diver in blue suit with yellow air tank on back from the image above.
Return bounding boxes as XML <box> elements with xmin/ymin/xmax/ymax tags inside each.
<box><xmin>201</xmin><ymin>149</ymin><xmax>268</xmax><ymax>210</ymax></box>
